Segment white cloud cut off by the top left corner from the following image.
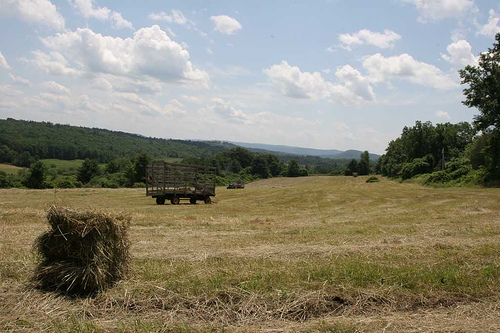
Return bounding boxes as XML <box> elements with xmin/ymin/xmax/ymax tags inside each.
<box><xmin>0</xmin><ymin>0</ymin><xmax>64</xmax><ymax>30</ymax></box>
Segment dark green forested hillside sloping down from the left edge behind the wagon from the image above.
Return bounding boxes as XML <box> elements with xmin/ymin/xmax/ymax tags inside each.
<box><xmin>0</xmin><ymin>118</ymin><xmax>234</xmax><ymax>166</ymax></box>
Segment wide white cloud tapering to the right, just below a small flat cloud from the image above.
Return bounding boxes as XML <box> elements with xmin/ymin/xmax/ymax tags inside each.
<box><xmin>363</xmin><ymin>53</ymin><xmax>458</xmax><ymax>89</ymax></box>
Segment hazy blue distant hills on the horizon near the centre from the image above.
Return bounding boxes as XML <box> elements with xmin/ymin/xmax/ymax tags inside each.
<box><xmin>231</xmin><ymin>141</ymin><xmax>380</xmax><ymax>161</ymax></box>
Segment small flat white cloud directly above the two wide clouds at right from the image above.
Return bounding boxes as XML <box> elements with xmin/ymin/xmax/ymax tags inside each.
<box><xmin>339</xmin><ymin>29</ymin><xmax>401</xmax><ymax>50</ymax></box>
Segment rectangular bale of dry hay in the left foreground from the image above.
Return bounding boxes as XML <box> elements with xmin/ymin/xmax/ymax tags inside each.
<box><xmin>35</xmin><ymin>206</ymin><xmax>130</xmax><ymax>295</ymax></box>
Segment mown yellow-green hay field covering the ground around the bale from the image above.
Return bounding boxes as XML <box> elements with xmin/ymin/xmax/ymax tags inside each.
<box><xmin>0</xmin><ymin>177</ymin><xmax>500</xmax><ymax>333</ymax></box>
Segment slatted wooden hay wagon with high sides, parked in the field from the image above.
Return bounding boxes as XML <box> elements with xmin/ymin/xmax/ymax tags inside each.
<box><xmin>146</xmin><ymin>161</ymin><xmax>215</xmax><ymax>205</ymax></box>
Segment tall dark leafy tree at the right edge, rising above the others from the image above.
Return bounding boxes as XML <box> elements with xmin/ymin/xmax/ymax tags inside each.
<box><xmin>460</xmin><ymin>33</ymin><xmax>500</xmax><ymax>178</ymax></box>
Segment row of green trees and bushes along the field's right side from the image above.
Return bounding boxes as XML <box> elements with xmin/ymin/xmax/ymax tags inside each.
<box><xmin>376</xmin><ymin>33</ymin><xmax>500</xmax><ymax>185</ymax></box>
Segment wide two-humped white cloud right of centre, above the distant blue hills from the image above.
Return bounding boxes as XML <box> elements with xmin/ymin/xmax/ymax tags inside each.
<box><xmin>264</xmin><ymin>61</ymin><xmax>375</xmax><ymax>104</ymax></box>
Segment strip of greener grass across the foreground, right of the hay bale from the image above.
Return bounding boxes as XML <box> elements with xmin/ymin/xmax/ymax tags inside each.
<box><xmin>134</xmin><ymin>256</ymin><xmax>500</xmax><ymax>297</ymax></box>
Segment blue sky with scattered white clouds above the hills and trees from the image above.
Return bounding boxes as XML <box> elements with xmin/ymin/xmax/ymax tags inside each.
<box><xmin>0</xmin><ymin>0</ymin><xmax>500</xmax><ymax>153</ymax></box>
